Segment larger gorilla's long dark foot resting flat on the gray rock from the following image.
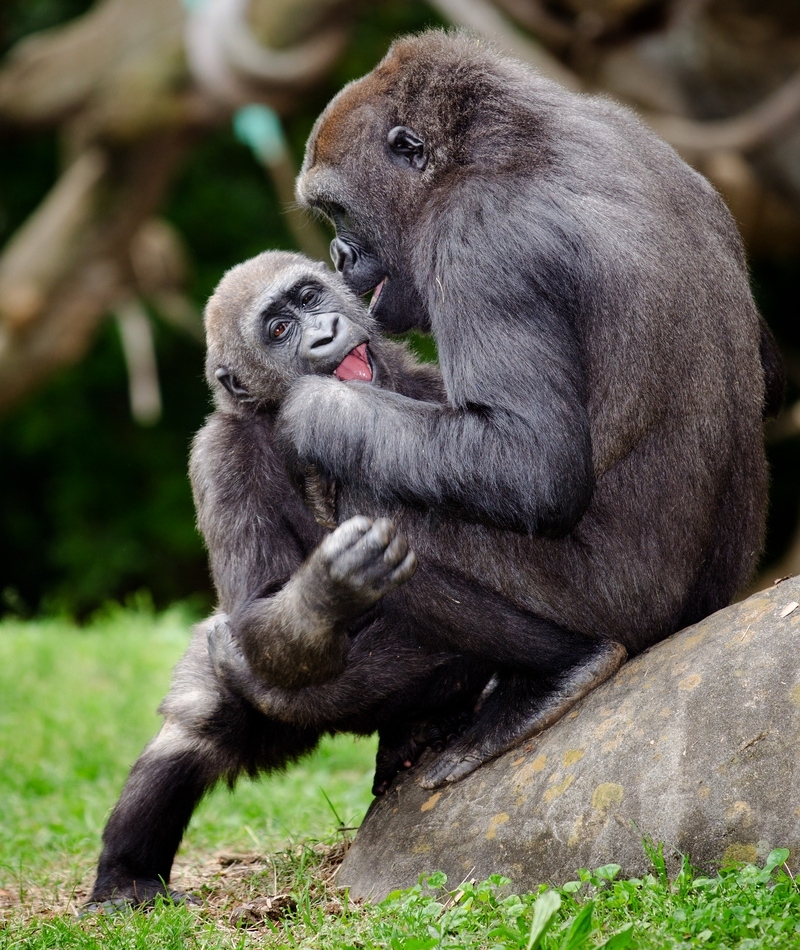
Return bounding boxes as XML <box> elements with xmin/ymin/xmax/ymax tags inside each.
<box><xmin>420</xmin><ymin>641</ymin><xmax>628</xmax><ymax>788</ymax></box>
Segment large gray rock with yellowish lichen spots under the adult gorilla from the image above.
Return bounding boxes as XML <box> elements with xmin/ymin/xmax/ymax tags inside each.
<box><xmin>338</xmin><ymin>577</ymin><xmax>800</xmax><ymax>898</ymax></box>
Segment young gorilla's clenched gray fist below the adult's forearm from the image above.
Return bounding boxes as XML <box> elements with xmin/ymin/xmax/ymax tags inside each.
<box><xmin>315</xmin><ymin>515</ymin><xmax>417</xmax><ymax>608</ymax></box>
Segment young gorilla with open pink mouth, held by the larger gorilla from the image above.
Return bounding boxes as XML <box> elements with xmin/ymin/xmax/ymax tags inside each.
<box><xmin>89</xmin><ymin>252</ymin><xmax>489</xmax><ymax>907</ymax></box>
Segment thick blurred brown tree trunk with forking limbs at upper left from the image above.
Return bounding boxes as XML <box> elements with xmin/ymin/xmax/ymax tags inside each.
<box><xmin>0</xmin><ymin>0</ymin><xmax>354</xmax><ymax>413</ymax></box>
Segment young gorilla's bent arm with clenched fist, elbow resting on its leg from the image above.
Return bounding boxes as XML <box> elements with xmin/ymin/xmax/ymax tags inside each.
<box><xmin>190</xmin><ymin>413</ymin><xmax>416</xmax><ymax>688</ymax></box>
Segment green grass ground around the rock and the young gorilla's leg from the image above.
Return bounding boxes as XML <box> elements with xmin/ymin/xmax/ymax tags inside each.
<box><xmin>0</xmin><ymin>608</ymin><xmax>800</xmax><ymax>950</ymax></box>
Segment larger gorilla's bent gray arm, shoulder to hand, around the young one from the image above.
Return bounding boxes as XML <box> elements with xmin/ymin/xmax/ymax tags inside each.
<box><xmin>279</xmin><ymin>174</ymin><xmax>594</xmax><ymax>536</ymax></box>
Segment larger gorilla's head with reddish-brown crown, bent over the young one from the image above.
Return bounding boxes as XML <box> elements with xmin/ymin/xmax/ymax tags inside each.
<box><xmin>297</xmin><ymin>31</ymin><xmax>576</xmax><ymax>332</ymax></box>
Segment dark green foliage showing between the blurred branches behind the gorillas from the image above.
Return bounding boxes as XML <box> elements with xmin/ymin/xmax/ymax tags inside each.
<box><xmin>0</xmin><ymin>0</ymin><xmax>800</xmax><ymax>617</ymax></box>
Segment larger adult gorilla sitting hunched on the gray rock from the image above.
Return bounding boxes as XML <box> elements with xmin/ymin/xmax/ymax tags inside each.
<box><xmin>280</xmin><ymin>32</ymin><xmax>782</xmax><ymax>784</ymax></box>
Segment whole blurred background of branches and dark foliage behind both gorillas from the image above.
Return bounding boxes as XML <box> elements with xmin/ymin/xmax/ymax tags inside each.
<box><xmin>0</xmin><ymin>0</ymin><xmax>800</xmax><ymax>619</ymax></box>
